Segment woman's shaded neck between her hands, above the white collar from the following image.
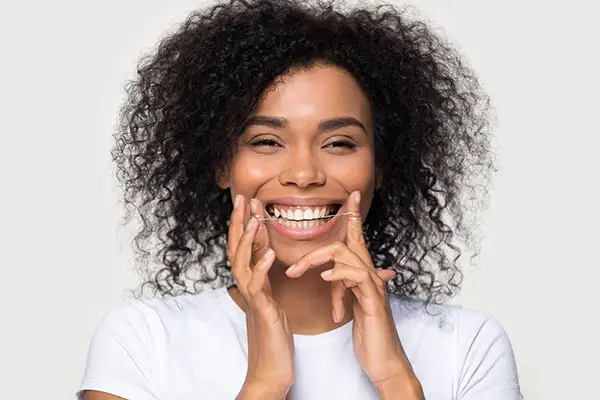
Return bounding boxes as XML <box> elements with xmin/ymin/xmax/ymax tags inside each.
<box><xmin>229</xmin><ymin>264</ymin><xmax>353</xmax><ymax>335</ymax></box>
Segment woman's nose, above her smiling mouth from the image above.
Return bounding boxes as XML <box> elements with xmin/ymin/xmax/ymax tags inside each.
<box><xmin>279</xmin><ymin>145</ymin><xmax>326</xmax><ymax>188</ymax></box>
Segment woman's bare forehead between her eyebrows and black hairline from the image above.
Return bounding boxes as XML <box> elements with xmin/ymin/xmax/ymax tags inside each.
<box><xmin>255</xmin><ymin>65</ymin><xmax>371</xmax><ymax>127</ymax></box>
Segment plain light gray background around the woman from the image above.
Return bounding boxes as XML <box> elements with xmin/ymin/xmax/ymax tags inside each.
<box><xmin>0</xmin><ymin>0</ymin><xmax>600</xmax><ymax>400</ymax></box>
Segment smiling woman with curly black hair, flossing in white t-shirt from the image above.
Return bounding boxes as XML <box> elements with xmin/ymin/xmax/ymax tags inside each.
<box><xmin>79</xmin><ymin>0</ymin><xmax>521</xmax><ymax>400</ymax></box>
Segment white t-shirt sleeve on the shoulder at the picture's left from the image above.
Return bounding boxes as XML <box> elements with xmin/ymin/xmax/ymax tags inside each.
<box><xmin>77</xmin><ymin>303</ymin><xmax>162</xmax><ymax>400</ymax></box>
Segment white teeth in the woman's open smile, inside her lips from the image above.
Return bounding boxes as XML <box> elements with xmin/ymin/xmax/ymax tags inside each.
<box><xmin>266</xmin><ymin>204</ymin><xmax>341</xmax><ymax>229</ymax></box>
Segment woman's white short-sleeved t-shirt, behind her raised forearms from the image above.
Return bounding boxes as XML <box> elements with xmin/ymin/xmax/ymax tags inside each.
<box><xmin>78</xmin><ymin>287</ymin><xmax>522</xmax><ymax>400</ymax></box>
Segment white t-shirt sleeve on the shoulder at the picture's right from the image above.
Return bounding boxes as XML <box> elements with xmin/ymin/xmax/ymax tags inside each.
<box><xmin>457</xmin><ymin>317</ymin><xmax>523</xmax><ymax>400</ymax></box>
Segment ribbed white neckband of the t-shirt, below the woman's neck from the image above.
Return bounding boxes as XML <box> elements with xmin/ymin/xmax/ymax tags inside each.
<box><xmin>215</xmin><ymin>286</ymin><xmax>354</xmax><ymax>347</ymax></box>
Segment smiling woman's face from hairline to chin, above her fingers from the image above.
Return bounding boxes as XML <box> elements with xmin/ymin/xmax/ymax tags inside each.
<box><xmin>222</xmin><ymin>65</ymin><xmax>375</xmax><ymax>265</ymax></box>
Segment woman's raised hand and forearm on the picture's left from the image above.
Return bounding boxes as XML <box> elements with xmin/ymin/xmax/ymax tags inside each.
<box><xmin>227</xmin><ymin>195</ymin><xmax>294</xmax><ymax>399</ymax></box>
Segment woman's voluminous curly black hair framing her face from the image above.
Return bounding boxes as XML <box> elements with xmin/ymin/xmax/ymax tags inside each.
<box><xmin>112</xmin><ymin>0</ymin><xmax>494</xmax><ymax>304</ymax></box>
